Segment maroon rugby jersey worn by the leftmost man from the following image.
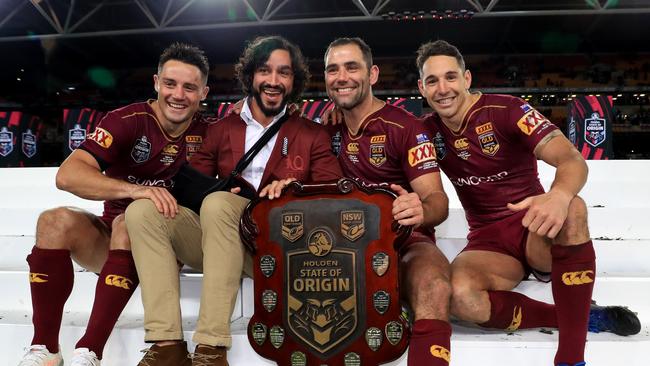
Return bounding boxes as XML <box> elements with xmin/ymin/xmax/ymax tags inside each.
<box><xmin>80</xmin><ymin>100</ymin><xmax>209</xmax><ymax>223</ymax></box>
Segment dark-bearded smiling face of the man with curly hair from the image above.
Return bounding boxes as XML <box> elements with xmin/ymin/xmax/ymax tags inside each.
<box><xmin>251</xmin><ymin>49</ymin><xmax>294</xmax><ymax>117</ymax></box>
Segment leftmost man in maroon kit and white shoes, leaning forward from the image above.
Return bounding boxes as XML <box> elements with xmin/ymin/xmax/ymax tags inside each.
<box><xmin>19</xmin><ymin>44</ymin><xmax>209</xmax><ymax>366</ymax></box>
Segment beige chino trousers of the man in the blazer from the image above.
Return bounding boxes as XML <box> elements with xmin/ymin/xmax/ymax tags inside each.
<box><xmin>126</xmin><ymin>192</ymin><xmax>252</xmax><ymax>347</ymax></box>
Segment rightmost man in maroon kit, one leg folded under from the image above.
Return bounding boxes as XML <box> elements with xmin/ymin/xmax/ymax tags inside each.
<box><xmin>417</xmin><ymin>41</ymin><xmax>640</xmax><ymax>366</ymax></box>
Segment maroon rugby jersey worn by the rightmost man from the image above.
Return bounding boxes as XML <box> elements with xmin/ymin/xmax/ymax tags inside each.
<box><xmin>425</xmin><ymin>95</ymin><xmax>557</xmax><ymax>230</ymax></box>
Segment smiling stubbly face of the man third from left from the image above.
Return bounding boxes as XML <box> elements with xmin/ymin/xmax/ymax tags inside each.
<box><xmin>325</xmin><ymin>44</ymin><xmax>379</xmax><ymax>110</ymax></box>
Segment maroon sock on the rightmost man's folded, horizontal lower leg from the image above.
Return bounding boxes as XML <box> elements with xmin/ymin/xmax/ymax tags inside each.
<box><xmin>479</xmin><ymin>291</ymin><xmax>557</xmax><ymax>331</ymax></box>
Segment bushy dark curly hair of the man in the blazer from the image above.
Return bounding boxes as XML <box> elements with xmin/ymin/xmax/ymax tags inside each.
<box><xmin>235</xmin><ymin>36</ymin><xmax>311</xmax><ymax>102</ymax></box>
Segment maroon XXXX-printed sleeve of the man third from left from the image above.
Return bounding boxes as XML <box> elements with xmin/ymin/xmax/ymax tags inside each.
<box><xmin>401</xmin><ymin>118</ymin><xmax>440</xmax><ymax>182</ymax></box>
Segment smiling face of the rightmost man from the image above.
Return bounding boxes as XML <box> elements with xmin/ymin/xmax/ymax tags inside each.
<box><xmin>418</xmin><ymin>56</ymin><xmax>472</xmax><ymax>124</ymax></box>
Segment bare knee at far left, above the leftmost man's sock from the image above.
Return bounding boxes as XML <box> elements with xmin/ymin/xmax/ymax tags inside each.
<box><xmin>36</xmin><ymin>207</ymin><xmax>77</xmax><ymax>249</ymax></box>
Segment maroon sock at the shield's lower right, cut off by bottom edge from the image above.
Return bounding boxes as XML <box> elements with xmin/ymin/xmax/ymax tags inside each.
<box><xmin>407</xmin><ymin>319</ymin><xmax>451</xmax><ymax>366</ymax></box>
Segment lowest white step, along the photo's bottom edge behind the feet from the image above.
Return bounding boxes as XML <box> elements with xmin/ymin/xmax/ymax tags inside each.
<box><xmin>0</xmin><ymin>318</ymin><xmax>650</xmax><ymax>366</ymax></box>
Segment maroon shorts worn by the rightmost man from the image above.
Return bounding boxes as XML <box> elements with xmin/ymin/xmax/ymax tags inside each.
<box><xmin>462</xmin><ymin>210</ymin><xmax>549</xmax><ymax>282</ymax></box>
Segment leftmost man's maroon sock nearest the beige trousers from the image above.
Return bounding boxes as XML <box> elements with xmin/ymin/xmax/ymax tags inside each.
<box><xmin>76</xmin><ymin>250</ymin><xmax>139</xmax><ymax>359</ymax></box>
